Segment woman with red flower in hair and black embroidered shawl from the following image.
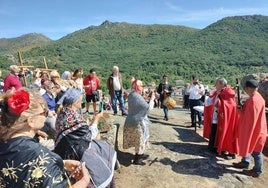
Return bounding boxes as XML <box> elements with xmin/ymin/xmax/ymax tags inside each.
<box><xmin>0</xmin><ymin>90</ymin><xmax>90</xmax><ymax>188</ymax></box>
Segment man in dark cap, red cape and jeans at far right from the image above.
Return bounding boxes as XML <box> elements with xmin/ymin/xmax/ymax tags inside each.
<box><xmin>233</xmin><ymin>79</ymin><xmax>267</xmax><ymax>177</ymax></box>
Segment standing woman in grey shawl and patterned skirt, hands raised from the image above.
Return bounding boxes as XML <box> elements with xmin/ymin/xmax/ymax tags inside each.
<box><xmin>123</xmin><ymin>79</ymin><xmax>155</xmax><ymax>165</ymax></box>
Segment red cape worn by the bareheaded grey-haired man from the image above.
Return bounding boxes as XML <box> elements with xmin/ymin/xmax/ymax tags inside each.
<box><xmin>203</xmin><ymin>87</ymin><xmax>238</xmax><ymax>153</ymax></box>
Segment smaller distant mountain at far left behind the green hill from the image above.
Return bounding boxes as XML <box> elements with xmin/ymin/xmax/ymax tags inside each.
<box><xmin>0</xmin><ymin>33</ymin><xmax>52</xmax><ymax>55</ymax></box>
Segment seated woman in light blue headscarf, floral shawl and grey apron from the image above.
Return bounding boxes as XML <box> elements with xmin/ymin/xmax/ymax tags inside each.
<box><xmin>55</xmin><ymin>88</ymin><xmax>116</xmax><ymax>187</ymax></box>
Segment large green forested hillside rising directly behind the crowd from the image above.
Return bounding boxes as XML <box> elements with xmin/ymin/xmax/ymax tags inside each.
<box><xmin>0</xmin><ymin>15</ymin><xmax>268</xmax><ymax>87</ymax></box>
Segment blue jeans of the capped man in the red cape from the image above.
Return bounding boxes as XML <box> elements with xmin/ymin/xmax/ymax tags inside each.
<box><xmin>241</xmin><ymin>151</ymin><xmax>263</xmax><ymax>175</ymax></box>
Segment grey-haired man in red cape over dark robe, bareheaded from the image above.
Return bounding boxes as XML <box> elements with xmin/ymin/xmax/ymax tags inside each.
<box><xmin>203</xmin><ymin>78</ymin><xmax>237</xmax><ymax>159</ymax></box>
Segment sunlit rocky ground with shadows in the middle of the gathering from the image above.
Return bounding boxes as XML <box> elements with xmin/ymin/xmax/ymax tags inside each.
<box><xmin>102</xmin><ymin>107</ymin><xmax>268</xmax><ymax>188</ymax></box>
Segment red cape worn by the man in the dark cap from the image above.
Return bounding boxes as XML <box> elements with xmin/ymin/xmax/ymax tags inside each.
<box><xmin>238</xmin><ymin>92</ymin><xmax>267</xmax><ymax>157</ymax></box>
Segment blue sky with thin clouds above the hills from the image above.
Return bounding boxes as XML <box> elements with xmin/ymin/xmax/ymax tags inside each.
<box><xmin>0</xmin><ymin>0</ymin><xmax>268</xmax><ymax>40</ymax></box>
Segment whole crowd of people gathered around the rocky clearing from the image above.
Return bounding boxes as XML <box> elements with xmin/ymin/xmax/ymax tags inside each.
<box><xmin>0</xmin><ymin>65</ymin><xmax>267</xmax><ymax>187</ymax></box>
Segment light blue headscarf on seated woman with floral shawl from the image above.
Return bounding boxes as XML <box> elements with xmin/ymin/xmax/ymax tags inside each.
<box><xmin>57</xmin><ymin>88</ymin><xmax>82</xmax><ymax>106</ymax></box>
